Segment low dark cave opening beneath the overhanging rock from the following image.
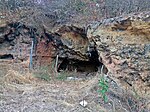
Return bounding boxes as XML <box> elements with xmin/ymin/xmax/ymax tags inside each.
<box><xmin>57</xmin><ymin>49</ymin><xmax>108</xmax><ymax>74</ymax></box>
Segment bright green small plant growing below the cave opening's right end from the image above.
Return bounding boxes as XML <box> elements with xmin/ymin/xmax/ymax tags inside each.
<box><xmin>98</xmin><ymin>76</ymin><xmax>109</xmax><ymax>103</ymax></box>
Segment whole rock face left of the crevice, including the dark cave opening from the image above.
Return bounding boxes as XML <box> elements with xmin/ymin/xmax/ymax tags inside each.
<box><xmin>0</xmin><ymin>22</ymin><xmax>102</xmax><ymax>72</ymax></box>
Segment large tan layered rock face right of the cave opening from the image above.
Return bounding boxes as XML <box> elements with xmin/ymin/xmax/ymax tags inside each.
<box><xmin>88</xmin><ymin>12</ymin><xmax>150</xmax><ymax>96</ymax></box>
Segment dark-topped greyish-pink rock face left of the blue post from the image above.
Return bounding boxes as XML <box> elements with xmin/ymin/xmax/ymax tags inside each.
<box><xmin>0</xmin><ymin>22</ymin><xmax>37</xmax><ymax>61</ymax></box>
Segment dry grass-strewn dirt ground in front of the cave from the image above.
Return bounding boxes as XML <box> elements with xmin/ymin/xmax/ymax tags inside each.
<box><xmin>0</xmin><ymin>65</ymin><xmax>149</xmax><ymax>112</ymax></box>
